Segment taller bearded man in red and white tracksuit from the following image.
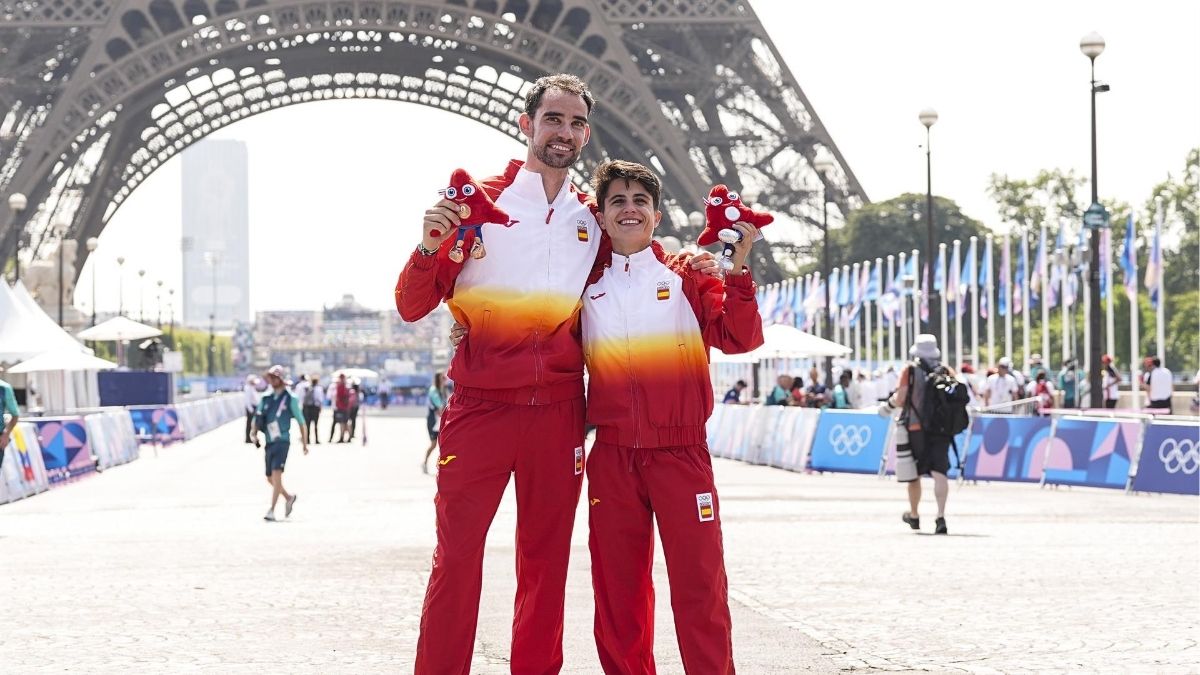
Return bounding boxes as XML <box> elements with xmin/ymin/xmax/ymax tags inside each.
<box><xmin>396</xmin><ymin>74</ymin><xmax>601</xmax><ymax>675</ymax></box>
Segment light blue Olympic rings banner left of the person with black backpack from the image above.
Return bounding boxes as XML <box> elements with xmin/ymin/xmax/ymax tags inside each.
<box><xmin>811</xmin><ymin>410</ymin><xmax>892</xmax><ymax>473</ymax></box>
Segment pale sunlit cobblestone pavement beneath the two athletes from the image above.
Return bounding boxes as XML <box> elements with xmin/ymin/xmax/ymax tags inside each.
<box><xmin>0</xmin><ymin>418</ymin><xmax>1200</xmax><ymax>675</ymax></box>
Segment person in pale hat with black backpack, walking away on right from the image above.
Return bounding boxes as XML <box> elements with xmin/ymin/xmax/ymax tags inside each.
<box><xmin>881</xmin><ymin>334</ymin><xmax>960</xmax><ymax>534</ymax></box>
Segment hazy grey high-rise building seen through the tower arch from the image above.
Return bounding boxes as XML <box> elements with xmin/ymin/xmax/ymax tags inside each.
<box><xmin>180</xmin><ymin>139</ymin><xmax>250</xmax><ymax>329</ymax></box>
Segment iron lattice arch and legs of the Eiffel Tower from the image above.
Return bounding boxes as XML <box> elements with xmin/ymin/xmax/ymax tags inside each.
<box><xmin>0</xmin><ymin>0</ymin><xmax>866</xmax><ymax>281</ymax></box>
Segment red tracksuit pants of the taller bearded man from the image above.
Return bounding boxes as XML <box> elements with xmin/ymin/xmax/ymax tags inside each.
<box><xmin>416</xmin><ymin>394</ymin><xmax>583</xmax><ymax>675</ymax></box>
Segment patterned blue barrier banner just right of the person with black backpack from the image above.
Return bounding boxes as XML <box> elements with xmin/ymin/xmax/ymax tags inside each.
<box><xmin>962</xmin><ymin>414</ymin><xmax>1050</xmax><ymax>483</ymax></box>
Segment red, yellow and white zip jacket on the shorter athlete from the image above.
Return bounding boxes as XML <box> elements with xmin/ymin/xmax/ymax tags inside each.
<box><xmin>583</xmin><ymin>241</ymin><xmax>763</xmax><ymax>448</ymax></box>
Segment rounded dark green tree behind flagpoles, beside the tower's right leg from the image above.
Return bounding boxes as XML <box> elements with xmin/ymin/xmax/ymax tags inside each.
<box><xmin>803</xmin><ymin>192</ymin><xmax>989</xmax><ymax>271</ymax></box>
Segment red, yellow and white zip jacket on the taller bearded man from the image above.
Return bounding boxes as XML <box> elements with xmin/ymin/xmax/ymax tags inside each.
<box><xmin>396</xmin><ymin>160</ymin><xmax>607</xmax><ymax>405</ymax></box>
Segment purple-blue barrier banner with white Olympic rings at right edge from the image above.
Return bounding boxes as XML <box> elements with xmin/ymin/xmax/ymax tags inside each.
<box><xmin>1133</xmin><ymin>420</ymin><xmax>1200</xmax><ymax>495</ymax></box>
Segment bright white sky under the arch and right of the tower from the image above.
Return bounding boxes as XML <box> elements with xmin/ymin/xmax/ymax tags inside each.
<box><xmin>76</xmin><ymin>0</ymin><xmax>1200</xmax><ymax>316</ymax></box>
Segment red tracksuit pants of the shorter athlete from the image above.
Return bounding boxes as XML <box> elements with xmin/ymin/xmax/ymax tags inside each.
<box><xmin>588</xmin><ymin>443</ymin><xmax>733</xmax><ymax>675</ymax></box>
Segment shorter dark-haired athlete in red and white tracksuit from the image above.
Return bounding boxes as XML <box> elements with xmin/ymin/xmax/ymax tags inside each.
<box><xmin>583</xmin><ymin>161</ymin><xmax>763</xmax><ymax>675</ymax></box>
